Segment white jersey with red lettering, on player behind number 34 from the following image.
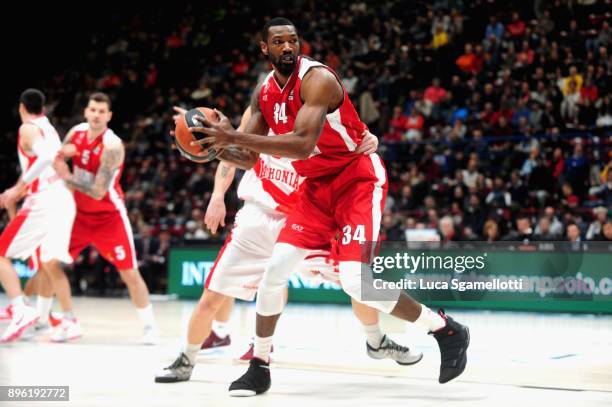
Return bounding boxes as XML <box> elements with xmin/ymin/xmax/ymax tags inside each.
<box><xmin>238</xmin><ymin>151</ymin><xmax>304</xmax><ymax>213</ymax></box>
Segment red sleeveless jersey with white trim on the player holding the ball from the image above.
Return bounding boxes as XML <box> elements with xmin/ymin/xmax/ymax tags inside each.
<box><xmin>259</xmin><ymin>56</ymin><xmax>366</xmax><ymax>177</ymax></box>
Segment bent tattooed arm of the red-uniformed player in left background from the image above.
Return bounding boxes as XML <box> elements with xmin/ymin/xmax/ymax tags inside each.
<box><xmin>53</xmin><ymin>141</ymin><xmax>125</xmax><ymax>200</ymax></box>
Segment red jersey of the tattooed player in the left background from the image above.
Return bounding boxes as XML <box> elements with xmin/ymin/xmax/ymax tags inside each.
<box><xmin>70</xmin><ymin>123</ymin><xmax>125</xmax><ymax>213</ymax></box>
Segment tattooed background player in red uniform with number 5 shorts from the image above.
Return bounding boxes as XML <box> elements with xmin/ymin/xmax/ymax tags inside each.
<box><xmin>52</xmin><ymin>93</ymin><xmax>158</xmax><ymax>344</ymax></box>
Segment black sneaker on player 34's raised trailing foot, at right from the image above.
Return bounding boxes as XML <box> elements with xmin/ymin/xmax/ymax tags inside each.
<box><xmin>429</xmin><ymin>310</ymin><xmax>470</xmax><ymax>383</ymax></box>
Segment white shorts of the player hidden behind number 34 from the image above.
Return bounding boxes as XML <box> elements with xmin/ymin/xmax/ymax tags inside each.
<box><xmin>204</xmin><ymin>202</ymin><xmax>339</xmax><ymax>301</ymax></box>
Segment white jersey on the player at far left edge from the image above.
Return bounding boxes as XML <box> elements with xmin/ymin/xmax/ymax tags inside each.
<box><xmin>17</xmin><ymin>116</ymin><xmax>66</xmax><ymax>196</ymax></box>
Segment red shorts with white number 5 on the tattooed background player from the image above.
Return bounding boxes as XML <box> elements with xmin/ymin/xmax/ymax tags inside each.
<box><xmin>70</xmin><ymin>211</ymin><xmax>138</xmax><ymax>270</ymax></box>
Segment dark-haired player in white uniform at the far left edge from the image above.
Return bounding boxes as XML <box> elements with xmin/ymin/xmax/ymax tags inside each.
<box><xmin>0</xmin><ymin>89</ymin><xmax>76</xmax><ymax>342</ymax></box>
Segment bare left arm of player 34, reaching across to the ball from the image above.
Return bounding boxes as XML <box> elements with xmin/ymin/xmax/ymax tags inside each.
<box><xmin>192</xmin><ymin>68</ymin><xmax>344</xmax><ymax>159</ymax></box>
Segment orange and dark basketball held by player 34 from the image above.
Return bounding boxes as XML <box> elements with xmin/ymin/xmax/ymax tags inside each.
<box><xmin>174</xmin><ymin>107</ymin><xmax>221</xmax><ymax>163</ymax></box>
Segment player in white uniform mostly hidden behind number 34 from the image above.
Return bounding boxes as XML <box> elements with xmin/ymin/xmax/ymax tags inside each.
<box><xmin>155</xmin><ymin>108</ymin><xmax>423</xmax><ymax>383</ymax></box>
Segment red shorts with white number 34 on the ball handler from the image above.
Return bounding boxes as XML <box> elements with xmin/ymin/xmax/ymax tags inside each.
<box><xmin>278</xmin><ymin>154</ymin><xmax>387</xmax><ymax>262</ymax></box>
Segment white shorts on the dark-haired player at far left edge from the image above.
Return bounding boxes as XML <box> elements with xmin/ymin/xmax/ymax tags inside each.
<box><xmin>0</xmin><ymin>188</ymin><xmax>76</xmax><ymax>263</ymax></box>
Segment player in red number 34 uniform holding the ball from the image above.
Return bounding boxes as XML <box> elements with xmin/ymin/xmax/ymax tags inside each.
<box><xmin>195</xmin><ymin>18</ymin><xmax>469</xmax><ymax>396</ymax></box>
